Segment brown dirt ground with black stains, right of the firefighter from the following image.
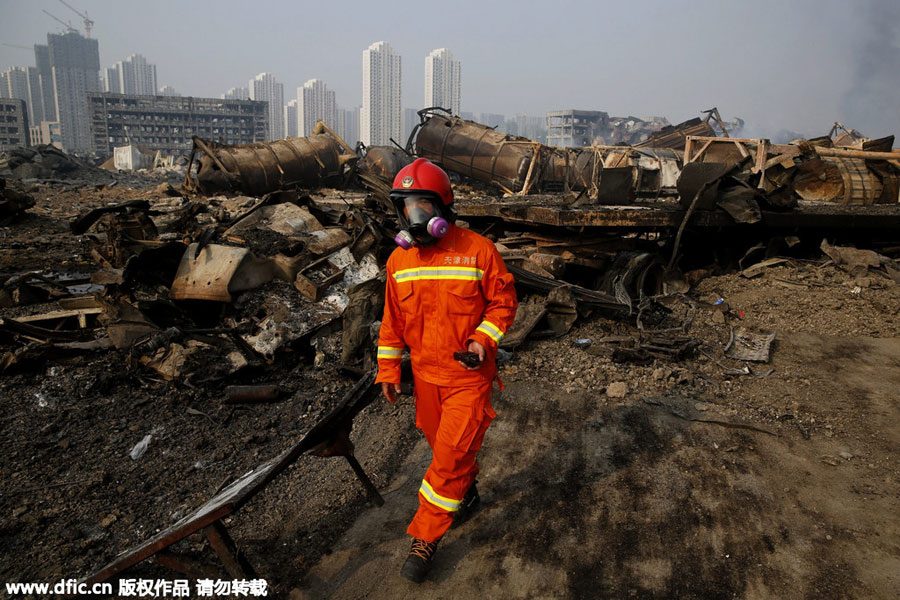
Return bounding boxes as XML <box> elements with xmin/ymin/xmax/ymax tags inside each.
<box><xmin>293</xmin><ymin>274</ymin><xmax>900</xmax><ymax>600</ymax></box>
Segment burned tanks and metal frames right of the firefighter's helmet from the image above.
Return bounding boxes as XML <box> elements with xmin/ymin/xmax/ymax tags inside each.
<box><xmin>415</xmin><ymin>112</ymin><xmax>900</xmax><ymax>211</ymax></box>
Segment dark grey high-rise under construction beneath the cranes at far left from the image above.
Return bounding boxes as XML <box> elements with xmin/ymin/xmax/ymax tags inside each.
<box><xmin>48</xmin><ymin>31</ymin><xmax>100</xmax><ymax>152</ymax></box>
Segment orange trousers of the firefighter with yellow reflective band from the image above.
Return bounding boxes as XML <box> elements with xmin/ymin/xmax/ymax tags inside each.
<box><xmin>406</xmin><ymin>377</ymin><xmax>497</xmax><ymax>542</ymax></box>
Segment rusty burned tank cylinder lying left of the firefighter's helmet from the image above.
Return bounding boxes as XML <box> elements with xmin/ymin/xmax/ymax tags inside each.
<box><xmin>185</xmin><ymin>121</ymin><xmax>358</xmax><ymax>196</ymax></box>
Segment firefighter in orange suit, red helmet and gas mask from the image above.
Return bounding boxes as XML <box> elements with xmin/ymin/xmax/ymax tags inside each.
<box><xmin>375</xmin><ymin>158</ymin><xmax>518</xmax><ymax>583</ymax></box>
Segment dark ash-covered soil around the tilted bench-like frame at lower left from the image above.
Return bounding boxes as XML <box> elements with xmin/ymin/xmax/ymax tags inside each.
<box><xmin>0</xmin><ymin>322</ymin><xmax>422</xmax><ymax>581</ymax></box>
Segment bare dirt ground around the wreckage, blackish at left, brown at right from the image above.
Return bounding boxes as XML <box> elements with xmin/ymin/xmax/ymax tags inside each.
<box><xmin>0</xmin><ymin>171</ymin><xmax>900</xmax><ymax>599</ymax></box>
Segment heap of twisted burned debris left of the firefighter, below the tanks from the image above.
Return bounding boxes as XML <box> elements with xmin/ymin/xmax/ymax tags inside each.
<box><xmin>0</xmin><ymin>192</ymin><xmax>383</xmax><ymax>380</ymax></box>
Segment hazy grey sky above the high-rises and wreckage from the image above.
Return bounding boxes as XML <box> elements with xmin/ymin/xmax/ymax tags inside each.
<box><xmin>0</xmin><ymin>0</ymin><xmax>900</xmax><ymax>137</ymax></box>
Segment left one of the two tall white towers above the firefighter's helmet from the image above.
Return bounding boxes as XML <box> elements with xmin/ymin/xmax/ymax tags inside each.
<box><xmin>359</xmin><ymin>42</ymin><xmax>403</xmax><ymax>146</ymax></box>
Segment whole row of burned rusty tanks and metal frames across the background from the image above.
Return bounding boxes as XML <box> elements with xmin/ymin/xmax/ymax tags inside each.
<box><xmin>179</xmin><ymin>109</ymin><xmax>900</xmax><ymax>213</ymax></box>
